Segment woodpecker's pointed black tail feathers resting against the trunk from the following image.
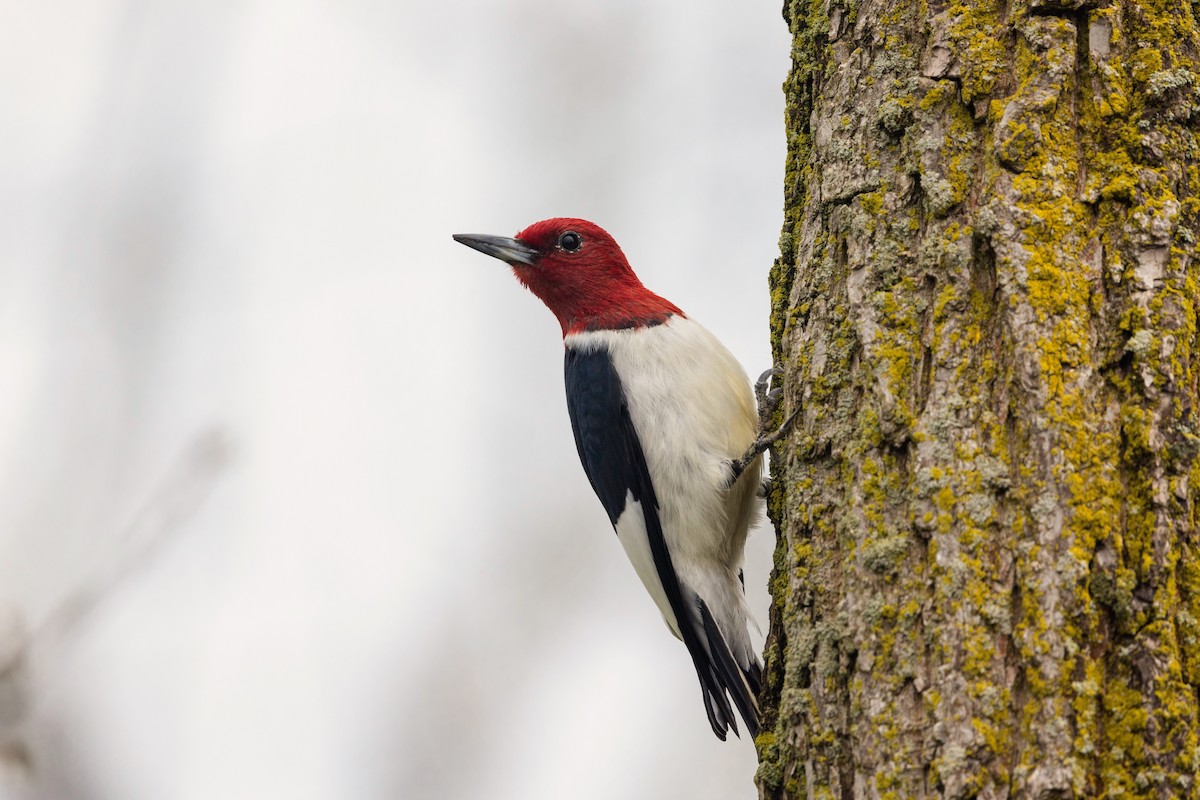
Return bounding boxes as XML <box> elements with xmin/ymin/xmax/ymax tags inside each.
<box><xmin>685</xmin><ymin>597</ymin><xmax>762</xmax><ymax>741</ymax></box>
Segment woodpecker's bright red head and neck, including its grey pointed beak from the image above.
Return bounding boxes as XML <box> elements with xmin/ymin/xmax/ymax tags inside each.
<box><xmin>455</xmin><ymin>217</ymin><xmax>683</xmax><ymax>336</ymax></box>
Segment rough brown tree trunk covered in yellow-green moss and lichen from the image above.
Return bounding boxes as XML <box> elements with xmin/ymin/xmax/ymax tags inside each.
<box><xmin>756</xmin><ymin>0</ymin><xmax>1200</xmax><ymax>798</ymax></box>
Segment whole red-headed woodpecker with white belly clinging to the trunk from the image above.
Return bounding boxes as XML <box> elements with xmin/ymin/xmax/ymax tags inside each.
<box><xmin>454</xmin><ymin>218</ymin><xmax>786</xmax><ymax>740</ymax></box>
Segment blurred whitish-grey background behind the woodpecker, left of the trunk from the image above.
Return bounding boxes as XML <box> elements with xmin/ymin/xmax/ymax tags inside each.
<box><xmin>0</xmin><ymin>0</ymin><xmax>788</xmax><ymax>800</ymax></box>
